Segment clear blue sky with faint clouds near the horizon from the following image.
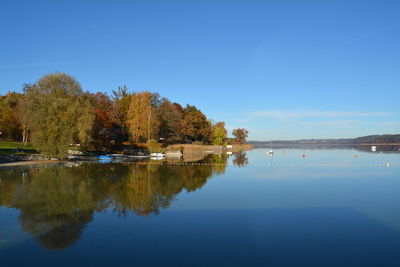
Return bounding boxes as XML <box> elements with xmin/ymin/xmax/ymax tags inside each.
<box><xmin>0</xmin><ymin>0</ymin><xmax>400</xmax><ymax>140</ymax></box>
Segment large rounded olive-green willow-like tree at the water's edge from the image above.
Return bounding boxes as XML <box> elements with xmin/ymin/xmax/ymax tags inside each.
<box><xmin>21</xmin><ymin>73</ymin><xmax>95</xmax><ymax>157</ymax></box>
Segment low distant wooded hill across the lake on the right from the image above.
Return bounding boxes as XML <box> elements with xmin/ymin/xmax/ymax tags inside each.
<box><xmin>248</xmin><ymin>134</ymin><xmax>400</xmax><ymax>147</ymax></box>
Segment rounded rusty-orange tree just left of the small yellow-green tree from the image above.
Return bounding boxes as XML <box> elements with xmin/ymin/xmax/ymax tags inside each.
<box><xmin>181</xmin><ymin>105</ymin><xmax>212</xmax><ymax>143</ymax></box>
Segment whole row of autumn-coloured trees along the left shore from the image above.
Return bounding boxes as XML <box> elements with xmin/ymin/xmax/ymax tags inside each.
<box><xmin>0</xmin><ymin>73</ymin><xmax>248</xmax><ymax>157</ymax></box>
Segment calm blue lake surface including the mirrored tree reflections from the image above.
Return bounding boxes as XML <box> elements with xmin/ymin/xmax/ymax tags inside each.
<box><xmin>0</xmin><ymin>149</ymin><xmax>400</xmax><ymax>266</ymax></box>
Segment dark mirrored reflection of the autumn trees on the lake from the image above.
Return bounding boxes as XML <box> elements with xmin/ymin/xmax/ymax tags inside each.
<box><xmin>0</xmin><ymin>155</ymin><xmax>226</xmax><ymax>250</ymax></box>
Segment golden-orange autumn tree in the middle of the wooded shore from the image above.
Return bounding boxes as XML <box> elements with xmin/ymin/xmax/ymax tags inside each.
<box><xmin>126</xmin><ymin>92</ymin><xmax>160</xmax><ymax>143</ymax></box>
